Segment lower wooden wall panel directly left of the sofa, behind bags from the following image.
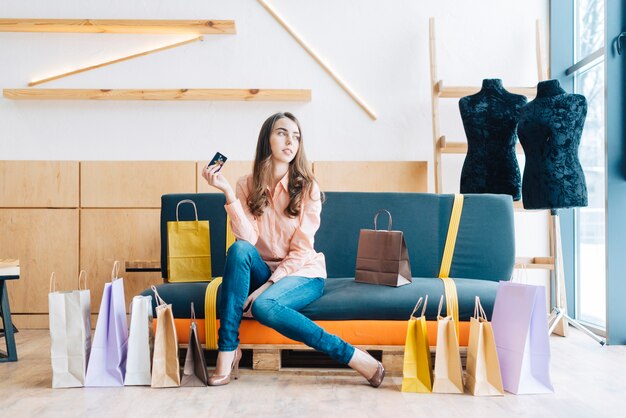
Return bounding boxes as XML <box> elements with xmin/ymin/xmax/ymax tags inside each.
<box><xmin>80</xmin><ymin>209</ymin><xmax>162</xmax><ymax>313</ymax></box>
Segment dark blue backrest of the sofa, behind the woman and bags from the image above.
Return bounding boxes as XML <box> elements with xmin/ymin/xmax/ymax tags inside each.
<box><xmin>161</xmin><ymin>192</ymin><xmax>515</xmax><ymax>281</ymax></box>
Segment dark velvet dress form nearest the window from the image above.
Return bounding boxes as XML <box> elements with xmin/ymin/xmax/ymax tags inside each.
<box><xmin>517</xmin><ymin>80</ymin><xmax>587</xmax><ymax>209</ymax></box>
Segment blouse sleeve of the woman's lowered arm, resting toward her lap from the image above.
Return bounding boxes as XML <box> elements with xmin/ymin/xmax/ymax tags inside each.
<box><xmin>269</xmin><ymin>183</ymin><xmax>322</xmax><ymax>283</ymax></box>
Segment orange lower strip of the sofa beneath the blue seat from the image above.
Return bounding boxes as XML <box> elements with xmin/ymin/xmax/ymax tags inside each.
<box><xmin>167</xmin><ymin>319</ymin><xmax>469</xmax><ymax>347</ymax></box>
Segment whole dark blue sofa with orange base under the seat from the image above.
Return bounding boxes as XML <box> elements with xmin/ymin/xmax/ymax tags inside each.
<box><xmin>142</xmin><ymin>192</ymin><xmax>515</xmax><ymax>354</ymax></box>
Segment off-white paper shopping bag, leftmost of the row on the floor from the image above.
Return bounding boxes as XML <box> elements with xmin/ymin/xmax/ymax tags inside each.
<box><xmin>47</xmin><ymin>270</ymin><xmax>91</xmax><ymax>388</ymax></box>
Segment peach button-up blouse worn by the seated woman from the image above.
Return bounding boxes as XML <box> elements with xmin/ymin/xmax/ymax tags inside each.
<box><xmin>224</xmin><ymin>174</ymin><xmax>326</xmax><ymax>283</ymax></box>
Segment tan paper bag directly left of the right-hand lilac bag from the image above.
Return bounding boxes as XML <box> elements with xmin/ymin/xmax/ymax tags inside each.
<box><xmin>465</xmin><ymin>296</ymin><xmax>504</xmax><ymax>396</ymax></box>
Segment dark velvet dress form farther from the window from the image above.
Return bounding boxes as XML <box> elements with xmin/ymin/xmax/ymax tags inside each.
<box><xmin>459</xmin><ymin>79</ymin><xmax>526</xmax><ymax>200</ymax></box>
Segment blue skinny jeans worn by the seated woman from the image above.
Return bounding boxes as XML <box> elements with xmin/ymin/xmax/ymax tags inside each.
<box><xmin>218</xmin><ymin>241</ymin><xmax>354</xmax><ymax>364</ymax></box>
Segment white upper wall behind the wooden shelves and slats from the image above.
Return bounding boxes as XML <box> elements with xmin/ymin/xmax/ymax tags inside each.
<box><xmin>0</xmin><ymin>0</ymin><xmax>548</xmax><ymax>280</ymax></box>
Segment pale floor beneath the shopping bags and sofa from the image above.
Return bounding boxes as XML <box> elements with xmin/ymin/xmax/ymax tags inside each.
<box><xmin>0</xmin><ymin>330</ymin><xmax>626</xmax><ymax>418</ymax></box>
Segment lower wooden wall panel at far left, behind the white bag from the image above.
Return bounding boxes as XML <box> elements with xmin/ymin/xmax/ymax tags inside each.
<box><xmin>0</xmin><ymin>209</ymin><xmax>78</xmax><ymax>313</ymax></box>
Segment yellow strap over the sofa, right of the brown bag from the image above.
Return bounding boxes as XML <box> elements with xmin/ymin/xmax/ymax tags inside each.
<box><xmin>439</xmin><ymin>194</ymin><xmax>463</xmax><ymax>337</ymax></box>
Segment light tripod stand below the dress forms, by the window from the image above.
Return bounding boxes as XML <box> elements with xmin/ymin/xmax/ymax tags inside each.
<box><xmin>548</xmin><ymin>209</ymin><xmax>606</xmax><ymax>345</ymax></box>
